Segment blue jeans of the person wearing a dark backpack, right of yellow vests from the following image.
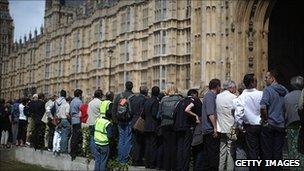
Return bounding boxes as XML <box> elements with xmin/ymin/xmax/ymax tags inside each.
<box><xmin>118</xmin><ymin>122</ymin><xmax>132</xmax><ymax>164</ymax></box>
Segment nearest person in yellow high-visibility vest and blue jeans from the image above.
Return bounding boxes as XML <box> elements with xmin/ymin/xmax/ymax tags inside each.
<box><xmin>94</xmin><ymin>115</ymin><xmax>112</xmax><ymax>171</ymax></box>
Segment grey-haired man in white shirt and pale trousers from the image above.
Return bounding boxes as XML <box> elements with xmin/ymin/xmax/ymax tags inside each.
<box><xmin>216</xmin><ymin>81</ymin><xmax>237</xmax><ymax>170</ymax></box>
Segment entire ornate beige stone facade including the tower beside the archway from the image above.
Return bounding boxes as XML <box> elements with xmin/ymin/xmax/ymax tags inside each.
<box><xmin>1</xmin><ymin>0</ymin><xmax>302</xmax><ymax>98</ymax></box>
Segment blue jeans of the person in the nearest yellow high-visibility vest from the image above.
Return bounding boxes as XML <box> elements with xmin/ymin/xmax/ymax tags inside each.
<box><xmin>94</xmin><ymin>144</ymin><xmax>110</xmax><ymax>171</ymax></box>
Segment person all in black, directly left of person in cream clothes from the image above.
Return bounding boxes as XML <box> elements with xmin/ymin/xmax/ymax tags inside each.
<box><xmin>29</xmin><ymin>93</ymin><xmax>46</xmax><ymax>150</ymax></box>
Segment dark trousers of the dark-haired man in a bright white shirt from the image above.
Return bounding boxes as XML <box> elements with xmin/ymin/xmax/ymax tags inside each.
<box><xmin>245</xmin><ymin>125</ymin><xmax>261</xmax><ymax>170</ymax></box>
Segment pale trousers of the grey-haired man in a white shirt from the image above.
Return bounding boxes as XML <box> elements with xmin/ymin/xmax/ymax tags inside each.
<box><xmin>219</xmin><ymin>133</ymin><xmax>234</xmax><ymax>170</ymax></box>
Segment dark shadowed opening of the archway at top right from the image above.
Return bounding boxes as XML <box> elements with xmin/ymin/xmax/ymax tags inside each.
<box><xmin>268</xmin><ymin>0</ymin><xmax>304</xmax><ymax>89</ymax></box>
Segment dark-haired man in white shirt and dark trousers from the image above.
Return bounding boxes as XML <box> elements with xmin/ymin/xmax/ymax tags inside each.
<box><xmin>235</xmin><ymin>74</ymin><xmax>263</xmax><ymax>169</ymax></box>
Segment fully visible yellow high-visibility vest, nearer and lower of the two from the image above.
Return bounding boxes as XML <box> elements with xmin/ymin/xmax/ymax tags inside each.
<box><xmin>94</xmin><ymin>117</ymin><xmax>111</xmax><ymax>146</ymax></box>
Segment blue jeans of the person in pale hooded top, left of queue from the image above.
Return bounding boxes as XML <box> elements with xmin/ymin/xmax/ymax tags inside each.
<box><xmin>60</xmin><ymin>119</ymin><xmax>70</xmax><ymax>153</ymax></box>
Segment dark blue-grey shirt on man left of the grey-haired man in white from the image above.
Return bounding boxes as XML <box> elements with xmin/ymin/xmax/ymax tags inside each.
<box><xmin>202</xmin><ymin>90</ymin><xmax>216</xmax><ymax>135</ymax></box>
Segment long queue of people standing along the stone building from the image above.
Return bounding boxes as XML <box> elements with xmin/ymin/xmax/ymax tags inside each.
<box><xmin>0</xmin><ymin>70</ymin><xmax>304</xmax><ymax>171</ymax></box>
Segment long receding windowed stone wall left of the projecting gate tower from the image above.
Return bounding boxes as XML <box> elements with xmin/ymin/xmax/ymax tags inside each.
<box><xmin>1</xmin><ymin>0</ymin><xmax>191</xmax><ymax>98</ymax></box>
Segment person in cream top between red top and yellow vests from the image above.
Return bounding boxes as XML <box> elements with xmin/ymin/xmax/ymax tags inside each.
<box><xmin>87</xmin><ymin>89</ymin><xmax>103</xmax><ymax>160</ymax></box>
